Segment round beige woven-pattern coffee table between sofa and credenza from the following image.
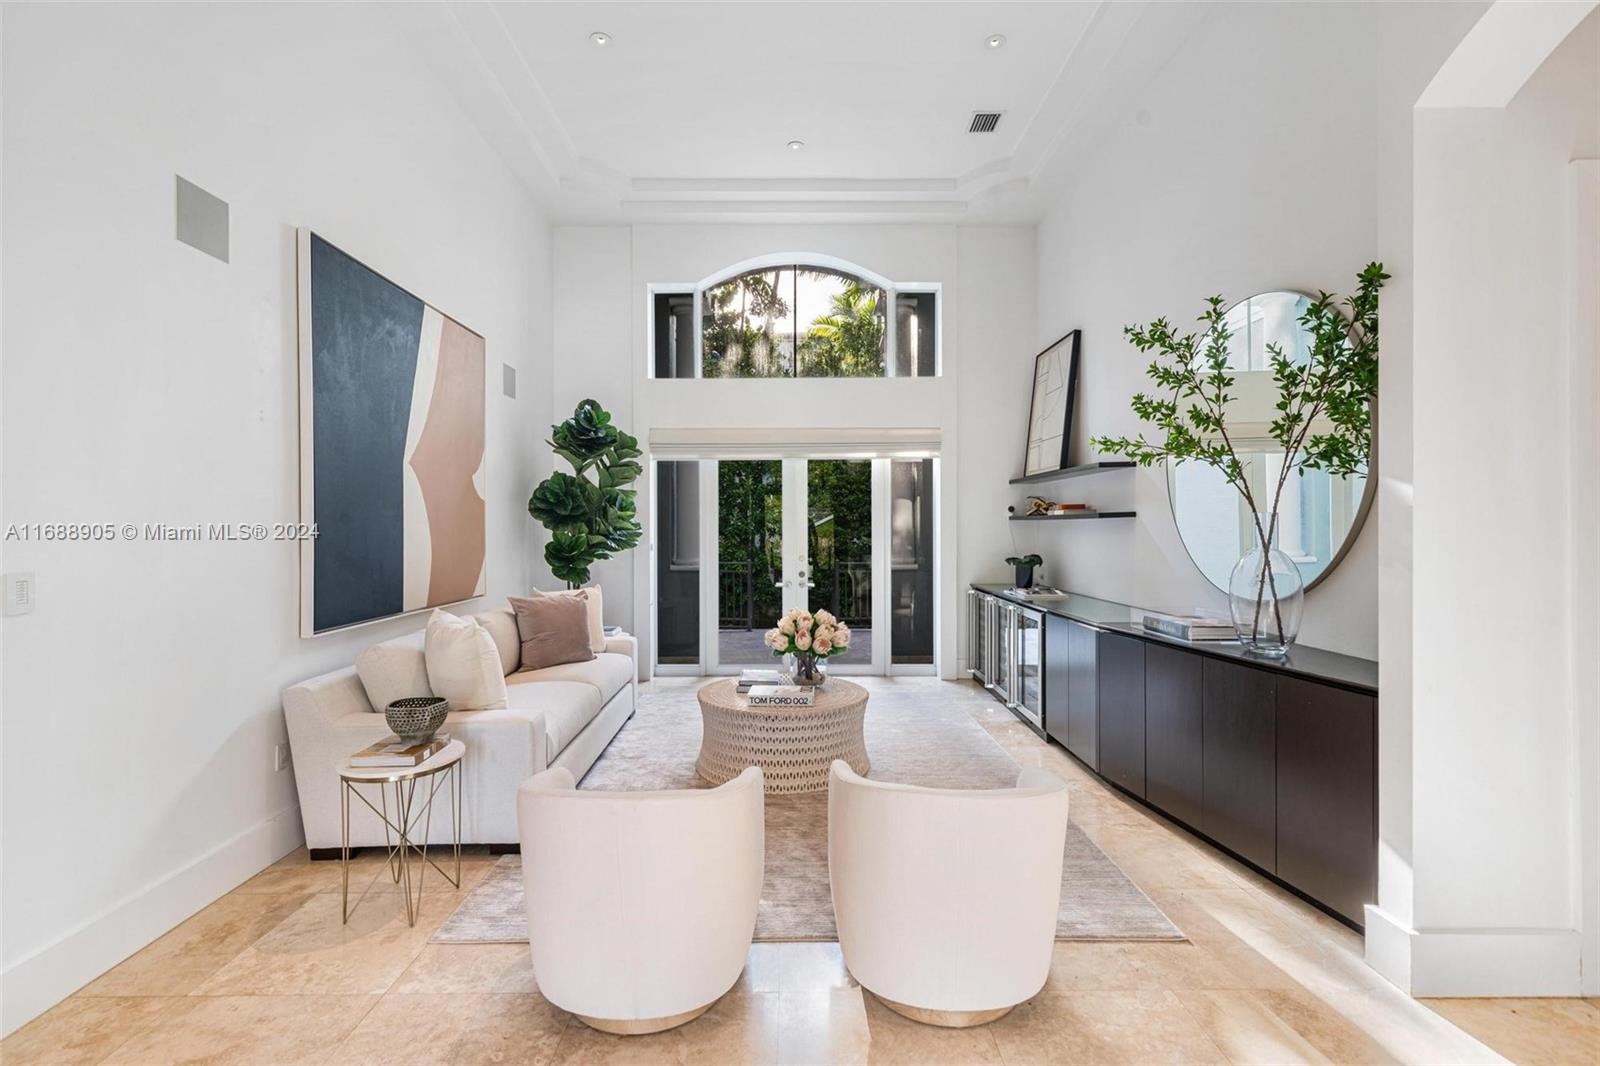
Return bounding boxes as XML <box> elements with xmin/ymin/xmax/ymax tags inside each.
<box><xmin>694</xmin><ymin>677</ymin><xmax>870</xmax><ymax>792</ymax></box>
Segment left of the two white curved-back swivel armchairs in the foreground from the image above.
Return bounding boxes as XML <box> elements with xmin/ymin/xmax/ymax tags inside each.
<box><xmin>517</xmin><ymin>767</ymin><xmax>765</xmax><ymax>1034</ymax></box>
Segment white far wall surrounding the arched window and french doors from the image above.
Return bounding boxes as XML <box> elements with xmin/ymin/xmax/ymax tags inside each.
<box><xmin>554</xmin><ymin>224</ymin><xmax>1034</xmax><ymax>677</ymax></box>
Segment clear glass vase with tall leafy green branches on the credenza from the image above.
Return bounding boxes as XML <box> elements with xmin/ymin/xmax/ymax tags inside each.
<box><xmin>1093</xmin><ymin>262</ymin><xmax>1389</xmax><ymax>658</ymax></box>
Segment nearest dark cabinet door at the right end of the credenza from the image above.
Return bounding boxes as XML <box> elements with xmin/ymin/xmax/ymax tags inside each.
<box><xmin>1277</xmin><ymin>677</ymin><xmax>1378</xmax><ymax>922</ymax></box>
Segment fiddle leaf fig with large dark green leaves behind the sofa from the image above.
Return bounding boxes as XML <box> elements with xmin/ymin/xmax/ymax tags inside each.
<box><xmin>528</xmin><ymin>400</ymin><xmax>645</xmax><ymax>589</ymax></box>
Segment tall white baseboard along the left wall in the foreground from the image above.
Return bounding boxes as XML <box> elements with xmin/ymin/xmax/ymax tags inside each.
<box><xmin>0</xmin><ymin>805</ymin><xmax>304</xmax><ymax>1036</ymax></box>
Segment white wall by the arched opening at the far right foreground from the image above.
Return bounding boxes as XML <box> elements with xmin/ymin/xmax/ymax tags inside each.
<box><xmin>1368</xmin><ymin>5</ymin><xmax>1600</xmax><ymax>996</ymax></box>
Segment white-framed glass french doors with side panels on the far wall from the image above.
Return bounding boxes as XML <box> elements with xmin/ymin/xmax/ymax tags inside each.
<box><xmin>651</xmin><ymin>459</ymin><xmax>934</xmax><ymax>674</ymax></box>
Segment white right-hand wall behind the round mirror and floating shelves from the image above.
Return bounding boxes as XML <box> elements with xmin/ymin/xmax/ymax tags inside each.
<box><xmin>1016</xmin><ymin>3</ymin><xmax>1410</xmax><ymax>658</ymax></box>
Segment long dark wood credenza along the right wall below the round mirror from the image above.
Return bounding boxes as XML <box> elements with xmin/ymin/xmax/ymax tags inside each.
<box><xmin>973</xmin><ymin>584</ymin><xmax>1378</xmax><ymax>928</ymax></box>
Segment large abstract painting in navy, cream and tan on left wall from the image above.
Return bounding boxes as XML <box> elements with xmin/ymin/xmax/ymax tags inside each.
<box><xmin>298</xmin><ymin>229</ymin><xmax>486</xmax><ymax>637</ymax></box>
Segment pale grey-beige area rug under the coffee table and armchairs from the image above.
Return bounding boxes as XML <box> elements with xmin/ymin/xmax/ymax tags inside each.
<box><xmin>432</xmin><ymin>679</ymin><xmax>1184</xmax><ymax>943</ymax></box>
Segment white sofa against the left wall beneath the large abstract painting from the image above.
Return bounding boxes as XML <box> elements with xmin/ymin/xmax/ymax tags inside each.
<box><xmin>283</xmin><ymin>607</ymin><xmax>638</xmax><ymax>858</ymax></box>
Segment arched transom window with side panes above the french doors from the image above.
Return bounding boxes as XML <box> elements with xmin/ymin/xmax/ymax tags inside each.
<box><xmin>651</xmin><ymin>256</ymin><xmax>939</xmax><ymax>378</ymax></box>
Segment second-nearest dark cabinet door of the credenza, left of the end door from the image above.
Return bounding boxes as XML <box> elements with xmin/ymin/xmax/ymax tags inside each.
<box><xmin>1200</xmin><ymin>659</ymin><xmax>1278</xmax><ymax>874</ymax></box>
